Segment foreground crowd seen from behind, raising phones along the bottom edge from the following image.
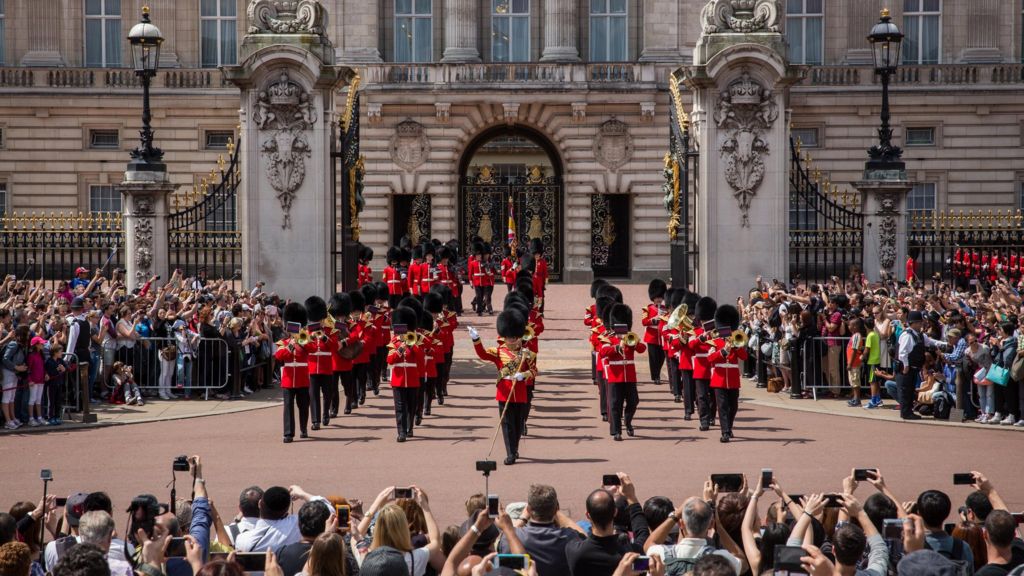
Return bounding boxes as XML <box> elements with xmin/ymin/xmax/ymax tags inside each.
<box><xmin>0</xmin><ymin>456</ymin><xmax>1024</xmax><ymax>576</ymax></box>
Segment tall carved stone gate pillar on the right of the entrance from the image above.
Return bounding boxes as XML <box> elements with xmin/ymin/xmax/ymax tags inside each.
<box><xmin>682</xmin><ymin>0</ymin><xmax>800</xmax><ymax>302</ymax></box>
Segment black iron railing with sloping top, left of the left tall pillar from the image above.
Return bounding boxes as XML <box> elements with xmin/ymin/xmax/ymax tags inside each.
<box><xmin>167</xmin><ymin>134</ymin><xmax>242</xmax><ymax>279</ymax></box>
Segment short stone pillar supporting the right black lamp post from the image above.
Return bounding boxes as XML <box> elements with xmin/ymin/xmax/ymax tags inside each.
<box><xmin>853</xmin><ymin>177</ymin><xmax>913</xmax><ymax>281</ymax></box>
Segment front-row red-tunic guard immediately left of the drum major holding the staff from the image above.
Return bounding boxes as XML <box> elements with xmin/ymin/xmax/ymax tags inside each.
<box><xmin>387</xmin><ymin>306</ymin><xmax>423</xmax><ymax>442</ymax></box>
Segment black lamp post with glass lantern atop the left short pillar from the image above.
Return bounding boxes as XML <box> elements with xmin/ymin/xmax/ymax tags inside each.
<box><xmin>128</xmin><ymin>6</ymin><xmax>167</xmax><ymax>172</ymax></box>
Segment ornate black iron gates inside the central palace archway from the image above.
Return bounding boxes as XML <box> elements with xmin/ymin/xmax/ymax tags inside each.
<box><xmin>459</xmin><ymin>166</ymin><xmax>562</xmax><ymax>281</ymax></box>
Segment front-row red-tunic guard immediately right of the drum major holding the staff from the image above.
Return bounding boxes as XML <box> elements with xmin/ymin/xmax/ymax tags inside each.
<box><xmin>597</xmin><ymin>304</ymin><xmax>647</xmax><ymax>442</ymax></box>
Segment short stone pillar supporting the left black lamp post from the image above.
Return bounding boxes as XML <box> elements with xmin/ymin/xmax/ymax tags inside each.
<box><xmin>118</xmin><ymin>176</ymin><xmax>178</xmax><ymax>291</ymax></box>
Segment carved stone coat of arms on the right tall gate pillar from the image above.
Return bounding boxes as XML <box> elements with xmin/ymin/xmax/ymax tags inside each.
<box><xmin>715</xmin><ymin>71</ymin><xmax>778</xmax><ymax>227</ymax></box>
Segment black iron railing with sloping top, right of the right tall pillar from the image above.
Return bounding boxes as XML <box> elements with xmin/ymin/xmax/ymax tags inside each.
<box><xmin>788</xmin><ymin>138</ymin><xmax>864</xmax><ymax>284</ymax></box>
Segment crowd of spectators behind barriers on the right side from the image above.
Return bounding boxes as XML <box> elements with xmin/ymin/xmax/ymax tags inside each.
<box><xmin>738</xmin><ymin>270</ymin><xmax>1024</xmax><ymax>426</ymax></box>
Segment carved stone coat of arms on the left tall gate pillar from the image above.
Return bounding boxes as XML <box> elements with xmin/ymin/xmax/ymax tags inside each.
<box><xmin>250</xmin><ymin>72</ymin><xmax>316</xmax><ymax>230</ymax></box>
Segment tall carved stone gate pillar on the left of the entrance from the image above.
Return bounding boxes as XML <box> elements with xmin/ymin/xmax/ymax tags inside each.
<box><xmin>223</xmin><ymin>0</ymin><xmax>354</xmax><ymax>301</ymax></box>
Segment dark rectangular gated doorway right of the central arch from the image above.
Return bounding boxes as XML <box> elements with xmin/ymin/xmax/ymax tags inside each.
<box><xmin>590</xmin><ymin>194</ymin><xmax>632</xmax><ymax>278</ymax></box>
